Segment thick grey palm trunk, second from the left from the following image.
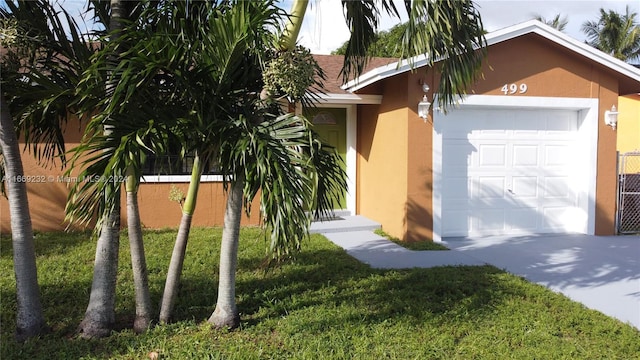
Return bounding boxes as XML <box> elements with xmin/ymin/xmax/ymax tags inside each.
<box><xmin>78</xmin><ymin>204</ymin><xmax>120</xmax><ymax>338</ymax></box>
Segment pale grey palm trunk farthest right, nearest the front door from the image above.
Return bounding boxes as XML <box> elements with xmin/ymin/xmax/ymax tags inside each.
<box><xmin>209</xmin><ymin>174</ymin><xmax>244</xmax><ymax>329</ymax></box>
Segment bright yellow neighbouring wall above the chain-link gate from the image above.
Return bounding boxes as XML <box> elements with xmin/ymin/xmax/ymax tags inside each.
<box><xmin>617</xmin><ymin>94</ymin><xmax>640</xmax><ymax>153</ymax></box>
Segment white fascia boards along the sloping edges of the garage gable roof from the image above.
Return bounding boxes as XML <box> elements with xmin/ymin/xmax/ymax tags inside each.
<box><xmin>342</xmin><ymin>20</ymin><xmax>640</xmax><ymax>93</ymax></box>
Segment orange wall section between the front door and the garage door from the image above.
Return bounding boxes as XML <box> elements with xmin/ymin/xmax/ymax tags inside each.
<box><xmin>356</xmin><ymin>69</ymin><xmax>433</xmax><ymax>241</ymax></box>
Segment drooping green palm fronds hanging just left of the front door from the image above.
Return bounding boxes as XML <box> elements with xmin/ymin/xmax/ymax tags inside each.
<box><xmin>220</xmin><ymin>114</ymin><xmax>346</xmax><ymax>259</ymax></box>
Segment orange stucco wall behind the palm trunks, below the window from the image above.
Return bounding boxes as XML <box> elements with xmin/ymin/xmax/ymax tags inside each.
<box><xmin>0</xmin><ymin>116</ymin><xmax>260</xmax><ymax>233</ymax></box>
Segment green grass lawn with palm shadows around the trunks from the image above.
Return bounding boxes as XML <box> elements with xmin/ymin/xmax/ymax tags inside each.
<box><xmin>0</xmin><ymin>228</ymin><xmax>640</xmax><ymax>359</ymax></box>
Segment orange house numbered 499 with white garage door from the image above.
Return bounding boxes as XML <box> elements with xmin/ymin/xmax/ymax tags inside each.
<box><xmin>0</xmin><ymin>21</ymin><xmax>640</xmax><ymax>241</ymax></box>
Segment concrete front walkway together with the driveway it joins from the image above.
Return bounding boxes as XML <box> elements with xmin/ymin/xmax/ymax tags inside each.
<box><xmin>311</xmin><ymin>216</ymin><xmax>640</xmax><ymax>329</ymax></box>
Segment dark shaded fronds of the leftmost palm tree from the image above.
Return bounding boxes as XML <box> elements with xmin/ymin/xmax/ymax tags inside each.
<box><xmin>0</xmin><ymin>0</ymin><xmax>96</xmax><ymax>165</ymax></box>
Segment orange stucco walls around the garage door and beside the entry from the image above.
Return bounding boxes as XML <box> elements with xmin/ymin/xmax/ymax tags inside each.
<box><xmin>357</xmin><ymin>35</ymin><xmax>640</xmax><ymax>241</ymax></box>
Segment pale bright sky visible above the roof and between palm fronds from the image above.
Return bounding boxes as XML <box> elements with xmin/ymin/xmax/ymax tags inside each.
<box><xmin>47</xmin><ymin>0</ymin><xmax>640</xmax><ymax>54</ymax></box>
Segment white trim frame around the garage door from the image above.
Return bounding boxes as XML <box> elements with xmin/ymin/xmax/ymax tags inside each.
<box><xmin>432</xmin><ymin>95</ymin><xmax>598</xmax><ymax>241</ymax></box>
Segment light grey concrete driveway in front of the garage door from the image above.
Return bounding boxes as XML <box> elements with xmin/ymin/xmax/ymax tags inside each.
<box><xmin>443</xmin><ymin>234</ymin><xmax>640</xmax><ymax>329</ymax></box>
